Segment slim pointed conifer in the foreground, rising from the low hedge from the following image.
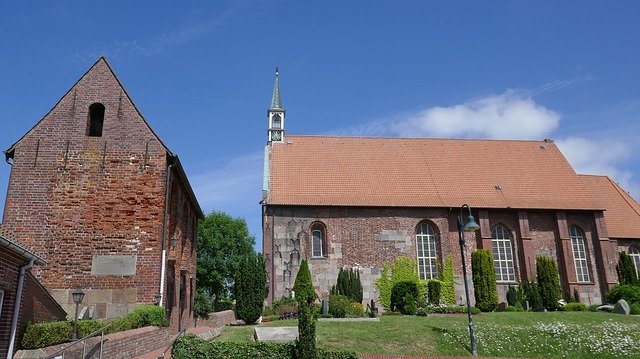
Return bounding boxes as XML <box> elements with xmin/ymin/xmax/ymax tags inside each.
<box><xmin>293</xmin><ymin>259</ymin><xmax>316</xmax><ymax>359</ymax></box>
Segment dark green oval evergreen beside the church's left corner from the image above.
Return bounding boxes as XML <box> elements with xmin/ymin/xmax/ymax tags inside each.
<box><xmin>234</xmin><ymin>254</ymin><xmax>267</xmax><ymax>324</ymax></box>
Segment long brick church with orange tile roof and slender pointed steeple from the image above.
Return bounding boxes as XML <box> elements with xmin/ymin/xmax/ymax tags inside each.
<box><xmin>261</xmin><ymin>70</ymin><xmax>640</xmax><ymax>304</ymax></box>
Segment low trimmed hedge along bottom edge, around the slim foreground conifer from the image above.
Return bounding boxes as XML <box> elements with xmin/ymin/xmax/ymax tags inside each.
<box><xmin>173</xmin><ymin>334</ymin><xmax>358</xmax><ymax>359</ymax></box>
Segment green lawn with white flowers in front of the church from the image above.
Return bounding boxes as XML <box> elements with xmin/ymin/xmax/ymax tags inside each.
<box><xmin>216</xmin><ymin>312</ymin><xmax>640</xmax><ymax>359</ymax></box>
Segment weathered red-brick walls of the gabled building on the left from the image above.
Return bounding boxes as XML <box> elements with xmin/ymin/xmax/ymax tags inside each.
<box><xmin>4</xmin><ymin>58</ymin><xmax>202</xmax><ymax>329</ymax></box>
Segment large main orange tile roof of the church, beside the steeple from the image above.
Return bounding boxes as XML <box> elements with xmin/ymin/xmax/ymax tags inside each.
<box><xmin>267</xmin><ymin>136</ymin><xmax>602</xmax><ymax>209</ymax></box>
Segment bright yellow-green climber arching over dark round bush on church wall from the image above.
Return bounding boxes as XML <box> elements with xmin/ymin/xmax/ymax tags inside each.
<box><xmin>376</xmin><ymin>257</ymin><xmax>420</xmax><ymax>311</ymax></box>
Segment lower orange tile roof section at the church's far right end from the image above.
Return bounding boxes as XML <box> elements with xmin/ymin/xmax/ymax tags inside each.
<box><xmin>580</xmin><ymin>175</ymin><xmax>640</xmax><ymax>238</ymax></box>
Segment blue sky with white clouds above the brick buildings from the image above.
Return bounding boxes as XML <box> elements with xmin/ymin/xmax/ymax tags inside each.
<box><xmin>0</xmin><ymin>0</ymin><xmax>640</xmax><ymax>252</ymax></box>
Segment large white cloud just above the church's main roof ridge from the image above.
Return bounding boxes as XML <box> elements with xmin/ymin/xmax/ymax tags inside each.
<box><xmin>390</xmin><ymin>90</ymin><xmax>560</xmax><ymax>139</ymax></box>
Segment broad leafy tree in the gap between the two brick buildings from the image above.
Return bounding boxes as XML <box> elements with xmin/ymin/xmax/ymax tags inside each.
<box><xmin>196</xmin><ymin>211</ymin><xmax>255</xmax><ymax>303</ymax></box>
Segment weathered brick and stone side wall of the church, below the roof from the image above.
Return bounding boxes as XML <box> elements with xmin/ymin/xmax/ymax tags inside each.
<box><xmin>263</xmin><ymin>205</ymin><xmax>617</xmax><ymax>304</ymax></box>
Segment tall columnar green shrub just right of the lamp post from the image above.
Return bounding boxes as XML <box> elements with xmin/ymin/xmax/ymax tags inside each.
<box><xmin>471</xmin><ymin>249</ymin><xmax>498</xmax><ymax>312</ymax></box>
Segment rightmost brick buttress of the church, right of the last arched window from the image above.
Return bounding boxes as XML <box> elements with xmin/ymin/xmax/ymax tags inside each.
<box><xmin>593</xmin><ymin>211</ymin><xmax>618</xmax><ymax>298</ymax></box>
